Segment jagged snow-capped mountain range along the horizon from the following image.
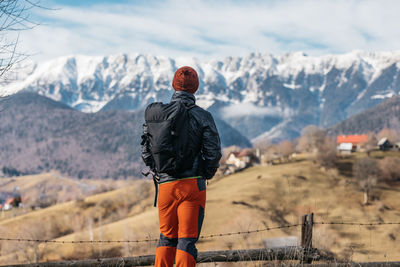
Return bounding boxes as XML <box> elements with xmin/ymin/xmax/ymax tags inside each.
<box><xmin>0</xmin><ymin>51</ymin><xmax>400</xmax><ymax>140</ymax></box>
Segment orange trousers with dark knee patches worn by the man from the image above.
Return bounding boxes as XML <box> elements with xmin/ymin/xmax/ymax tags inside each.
<box><xmin>155</xmin><ymin>178</ymin><xmax>206</xmax><ymax>267</ymax></box>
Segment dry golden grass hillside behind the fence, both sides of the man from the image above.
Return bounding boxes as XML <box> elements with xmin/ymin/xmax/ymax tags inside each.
<box><xmin>0</xmin><ymin>153</ymin><xmax>400</xmax><ymax>264</ymax></box>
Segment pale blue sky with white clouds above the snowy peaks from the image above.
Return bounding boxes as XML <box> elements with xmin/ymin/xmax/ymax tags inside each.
<box><xmin>15</xmin><ymin>0</ymin><xmax>400</xmax><ymax>60</ymax></box>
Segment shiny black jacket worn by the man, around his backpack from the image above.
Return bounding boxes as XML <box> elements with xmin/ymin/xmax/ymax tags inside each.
<box><xmin>142</xmin><ymin>91</ymin><xmax>222</xmax><ymax>183</ymax></box>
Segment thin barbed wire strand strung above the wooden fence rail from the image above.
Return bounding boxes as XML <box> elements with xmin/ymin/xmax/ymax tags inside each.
<box><xmin>0</xmin><ymin>221</ymin><xmax>400</xmax><ymax>244</ymax></box>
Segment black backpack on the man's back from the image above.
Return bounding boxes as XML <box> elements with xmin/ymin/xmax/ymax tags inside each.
<box><xmin>144</xmin><ymin>101</ymin><xmax>195</xmax><ymax>175</ymax></box>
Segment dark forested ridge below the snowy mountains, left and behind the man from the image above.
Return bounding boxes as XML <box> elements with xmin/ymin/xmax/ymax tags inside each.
<box><xmin>0</xmin><ymin>92</ymin><xmax>251</xmax><ymax>179</ymax></box>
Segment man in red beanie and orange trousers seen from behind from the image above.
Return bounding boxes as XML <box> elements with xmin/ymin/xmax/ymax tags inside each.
<box><xmin>142</xmin><ymin>67</ymin><xmax>221</xmax><ymax>267</ymax></box>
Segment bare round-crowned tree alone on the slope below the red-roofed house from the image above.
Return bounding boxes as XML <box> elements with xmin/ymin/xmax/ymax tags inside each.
<box><xmin>353</xmin><ymin>158</ymin><xmax>380</xmax><ymax>205</ymax></box>
